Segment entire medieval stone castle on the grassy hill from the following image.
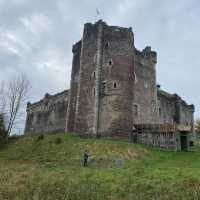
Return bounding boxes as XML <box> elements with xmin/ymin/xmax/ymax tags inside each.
<box><xmin>25</xmin><ymin>20</ymin><xmax>194</xmax><ymax>150</ymax></box>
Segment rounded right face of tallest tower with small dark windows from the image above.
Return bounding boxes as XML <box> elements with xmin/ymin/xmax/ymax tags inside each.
<box><xmin>98</xmin><ymin>22</ymin><xmax>134</xmax><ymax>137</ymax></box>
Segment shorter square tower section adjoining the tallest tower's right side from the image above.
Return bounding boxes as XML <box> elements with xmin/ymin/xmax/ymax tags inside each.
<box><xmin>133</xmin><ymin>47</ymin><xmax>157</xmax><ymax>124</ymax></box>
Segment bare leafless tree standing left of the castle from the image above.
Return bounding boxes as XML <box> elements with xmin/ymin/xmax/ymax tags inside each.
<box><xmin>0</xmin><ymin>74</ymin><xmax>30</xmax><ymax>137</ymax></box>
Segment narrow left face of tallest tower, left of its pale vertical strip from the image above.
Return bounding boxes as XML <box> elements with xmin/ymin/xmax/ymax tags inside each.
<box><xmin>70</xmin><ymin>23</ymin><xmax>100</xmax><ymax>134</ymax></box>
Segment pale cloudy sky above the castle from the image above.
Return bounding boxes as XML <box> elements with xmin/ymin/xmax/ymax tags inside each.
<box><xmin>0</xmin><ymin>0</ymin><xmax>200</xmax><ymax>132</ymax></box>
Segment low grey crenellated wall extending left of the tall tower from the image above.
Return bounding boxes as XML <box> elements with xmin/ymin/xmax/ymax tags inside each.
<box><xmin>25</xmin><ymin>91</ymin><xmax>68</xmax><ymax>134</ymax></box>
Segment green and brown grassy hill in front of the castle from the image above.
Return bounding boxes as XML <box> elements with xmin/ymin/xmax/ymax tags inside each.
<box><xmin>0</xmin><ymin>134</ymin><xmax>200</xmax><ymax>200</ymax></box>
